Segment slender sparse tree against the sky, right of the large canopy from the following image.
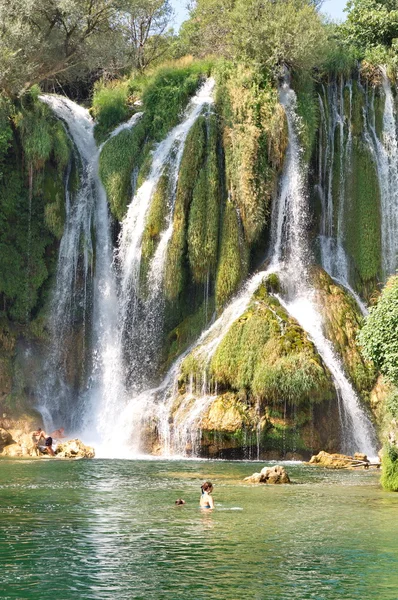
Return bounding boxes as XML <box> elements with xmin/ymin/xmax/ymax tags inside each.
<box><xmin>117</xmin><ymin>0</ymin><xmax>174</xmax><ymax>71</ymax></box>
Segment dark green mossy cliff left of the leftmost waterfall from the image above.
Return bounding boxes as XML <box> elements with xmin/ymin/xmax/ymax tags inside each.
<box><xmin>0</xmin><ymin>94</ymin><xmax>71</xmax><ymax>323</ymax></box>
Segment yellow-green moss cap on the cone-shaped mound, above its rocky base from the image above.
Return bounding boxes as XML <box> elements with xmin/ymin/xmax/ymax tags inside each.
<box><xmin>205</xmin><ymin>286</ymin><xmax>333</xmax><ymax>404</ymax></box>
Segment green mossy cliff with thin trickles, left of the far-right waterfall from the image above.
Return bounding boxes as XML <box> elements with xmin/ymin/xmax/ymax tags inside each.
<box><xmin>310</xmin><ymin>73</ymin><xmax>384</xmax><ymax>300</ymax></box>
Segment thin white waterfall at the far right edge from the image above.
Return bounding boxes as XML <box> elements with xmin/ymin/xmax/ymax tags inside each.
<box><xmin>364</xmin><ymin>67</ymin><xmax>398</xmax><ymax>280</ymax></box>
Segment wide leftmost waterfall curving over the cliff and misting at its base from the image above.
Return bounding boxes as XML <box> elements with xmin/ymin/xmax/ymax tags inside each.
<box><xmin>38</xmin><ymin>96</ymin><xmax>140</xmax><ymax>439</ymax></box>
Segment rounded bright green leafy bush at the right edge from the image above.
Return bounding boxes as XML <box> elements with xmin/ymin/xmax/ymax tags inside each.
<box><xmin>359</xmin><ymin>276</ymin><xmax>398</xmax><ymax>385</ymax></box>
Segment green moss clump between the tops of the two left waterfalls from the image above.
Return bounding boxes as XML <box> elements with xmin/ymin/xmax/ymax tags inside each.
<box><xmin>99</xmin><ymin>121</ymin><xmax>146</xmax><ymax>221</ymax></box>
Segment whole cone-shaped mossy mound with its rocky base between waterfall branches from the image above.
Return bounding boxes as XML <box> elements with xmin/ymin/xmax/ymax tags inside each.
<box><xmin>166</xmin><ymin>285</ymin><xmax>339</xmax><ymax>457</ymax></box>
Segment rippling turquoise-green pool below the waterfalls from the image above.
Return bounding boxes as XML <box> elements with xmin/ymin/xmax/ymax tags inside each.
<box><xmin>0</xmin><ymin>459</ymin><xmax>398</xmax><ymax>600</ymax></box>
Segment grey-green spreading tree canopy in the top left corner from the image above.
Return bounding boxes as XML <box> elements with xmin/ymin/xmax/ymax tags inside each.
<box><xmin>0</xmin><ymin>0</ymin><xmax>119</xmax><ymax>96</ymax></box>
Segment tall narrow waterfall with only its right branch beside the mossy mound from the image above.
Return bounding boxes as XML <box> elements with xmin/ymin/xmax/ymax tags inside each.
<box><xmin>271</xmin><ymin>79</ymin><xmax>376</xmax><ymax>456</ymax></box>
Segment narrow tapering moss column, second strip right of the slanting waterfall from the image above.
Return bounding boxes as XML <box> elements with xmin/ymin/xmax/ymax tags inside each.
<box><xmin>187</xmin><ymin>115</ymin><xmax>220</xmax><ymax>283</ymax></box>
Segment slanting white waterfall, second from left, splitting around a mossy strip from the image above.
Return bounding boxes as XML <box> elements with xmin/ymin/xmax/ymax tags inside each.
<box><xmin>117</xmin><ymin>78</ymin><xmax>214</xmax><ymax>393</ymax></box>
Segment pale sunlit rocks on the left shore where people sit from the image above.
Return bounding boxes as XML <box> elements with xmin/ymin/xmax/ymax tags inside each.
<box><xmin>0</xmin><ymin>428</ymin><xmax>95</xmax><ymax>458</ymax></box>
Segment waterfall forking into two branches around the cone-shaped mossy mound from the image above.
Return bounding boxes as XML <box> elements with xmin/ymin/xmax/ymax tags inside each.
<box><xmin>150</xmin><ymin>77</ymin><xmax>376</xmax><ymax>456</ymax></box>
